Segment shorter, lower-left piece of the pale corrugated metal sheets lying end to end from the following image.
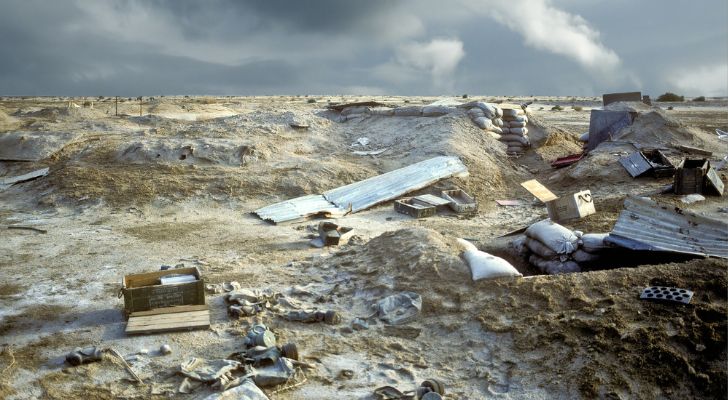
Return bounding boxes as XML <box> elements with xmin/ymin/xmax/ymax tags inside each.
<box><xmin>253</xmin><ymin>194</ymin><xmax>345</xmax><ymax>224</ymax></box>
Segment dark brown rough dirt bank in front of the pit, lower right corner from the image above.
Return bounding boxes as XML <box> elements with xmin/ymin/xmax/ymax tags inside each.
<box><xmin>478</xmin><ymin>259</ymin><xmax>728</xmax><ymax>398</ymax></box>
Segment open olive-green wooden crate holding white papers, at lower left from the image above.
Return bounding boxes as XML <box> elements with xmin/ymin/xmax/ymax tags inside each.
<box><xmin>121</xmin><ymin>267</ymin><xmax>205</xmax><ymax>317</ymax></box>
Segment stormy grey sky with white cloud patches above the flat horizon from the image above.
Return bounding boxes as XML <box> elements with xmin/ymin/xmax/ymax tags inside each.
<box><xmin>0</xmin><ymin>0</ymin><xmax>728</xmax><ymax>97</ymax></box>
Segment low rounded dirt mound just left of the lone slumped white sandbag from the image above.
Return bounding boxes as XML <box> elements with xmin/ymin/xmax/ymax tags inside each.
<box><xmin>335</xmin><ymin>228</ymin><xmax>471</xmax><ymax>311</ymax></box>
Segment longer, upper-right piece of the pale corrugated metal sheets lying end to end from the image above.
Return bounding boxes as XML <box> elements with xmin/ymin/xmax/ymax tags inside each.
<box><xmin>324</xmin><ymin>156</ymin><xmax>468</xmax><ymax>212</ymax></box>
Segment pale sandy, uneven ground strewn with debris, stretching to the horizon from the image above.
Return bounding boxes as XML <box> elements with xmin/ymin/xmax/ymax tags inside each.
<box><xmin>0</xmin><ymin>96</ymin><xmax>728</xmax><ymax>399</ymax></box>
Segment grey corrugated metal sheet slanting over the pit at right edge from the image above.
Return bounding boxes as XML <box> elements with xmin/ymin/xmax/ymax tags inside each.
<box><xmin>606</xmin><ymin>196</ymin><xmax>728</xmax><ymax>258</ymax></box>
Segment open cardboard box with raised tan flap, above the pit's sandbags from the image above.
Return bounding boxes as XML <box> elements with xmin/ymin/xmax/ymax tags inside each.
<box><xmin>521</xmin><ymin>179</ymin><xmax>596</xmax><ymax>222</ymax></box>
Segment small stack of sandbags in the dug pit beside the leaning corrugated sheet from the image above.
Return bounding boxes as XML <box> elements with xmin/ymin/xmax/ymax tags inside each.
<box><xmin>524</xmin><ymin>219</ymin><xmax>581</xmax><ymax>274</ymax></box>
